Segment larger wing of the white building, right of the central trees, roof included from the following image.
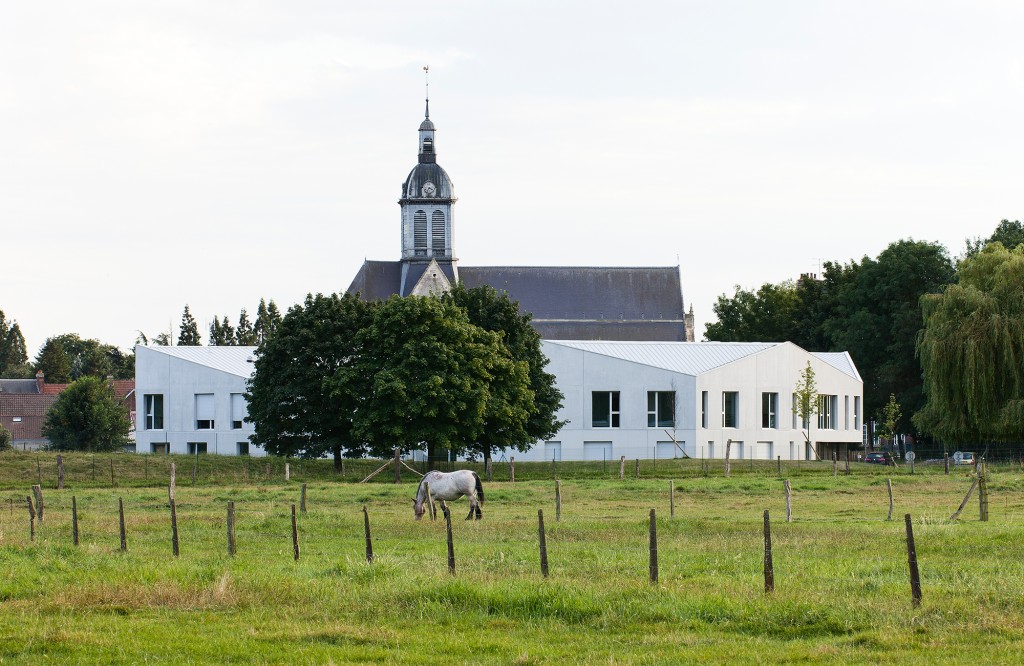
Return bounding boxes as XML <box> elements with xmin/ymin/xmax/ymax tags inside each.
<box><xmin>504</xmin><ymin>340</ymin><xmax>863</xmax><ymax>460</ymax></box>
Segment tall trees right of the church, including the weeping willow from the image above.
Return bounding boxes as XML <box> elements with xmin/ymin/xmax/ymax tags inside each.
<box><xmin>705</xmin><ymin>220</ymin><xmax>1024</xmax><ymax>442</ymax></box>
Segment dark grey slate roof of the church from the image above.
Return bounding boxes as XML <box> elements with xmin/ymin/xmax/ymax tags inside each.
<box><xmin>348</xmin><ymin>261</ymin><xmax>686</xmax><ymax>342</ymax></box>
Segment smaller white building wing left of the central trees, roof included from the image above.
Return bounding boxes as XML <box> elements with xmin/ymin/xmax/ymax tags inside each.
<box><xmin>135</xmin><ymin>345</ymin><xmax>266</xmax><ymax>456</ymax></box>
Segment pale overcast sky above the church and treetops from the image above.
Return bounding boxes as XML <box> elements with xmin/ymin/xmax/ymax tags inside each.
<box><xmin>0</xmin><ymin>0</ymin><xmax>1024</xmax><ymax>358</ymax></box>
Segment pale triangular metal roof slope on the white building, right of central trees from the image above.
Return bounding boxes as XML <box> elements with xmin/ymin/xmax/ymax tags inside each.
<box><xmin>545</xmin><ymin>340</ymin><xmax>779</xmax><ymax>375</ymax></box>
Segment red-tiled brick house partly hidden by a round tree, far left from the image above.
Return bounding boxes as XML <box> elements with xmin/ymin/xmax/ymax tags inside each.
<box><xmin>0</xmin><ymin>371</ymin><xmax>135</xmax><ymax>451</ymax></box>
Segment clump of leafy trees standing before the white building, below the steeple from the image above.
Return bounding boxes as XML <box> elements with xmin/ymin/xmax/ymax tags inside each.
<box><xmin>246</xmin><ymin>287</ymin><xmax>563</xmax><ymax>466</ymax></box>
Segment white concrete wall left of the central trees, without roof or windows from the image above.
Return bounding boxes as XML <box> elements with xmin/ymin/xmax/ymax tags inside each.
<box><xmin>135</xmin><ymin>346</ymin><xmax>266</xmax><ymax>456</ymax></box>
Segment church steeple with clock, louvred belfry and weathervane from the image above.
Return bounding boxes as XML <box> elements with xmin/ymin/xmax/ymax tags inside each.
<box><xmin>398</xmin><ymin>67</ymin><xmax>457</xmax><ymax>269</ymax></box>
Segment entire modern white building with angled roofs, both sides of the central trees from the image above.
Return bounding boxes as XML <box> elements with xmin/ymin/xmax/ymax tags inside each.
<box><xmin>135</xmin><ymin>340</ymin><xmax>863</xmax><ymax>460</ymax></box>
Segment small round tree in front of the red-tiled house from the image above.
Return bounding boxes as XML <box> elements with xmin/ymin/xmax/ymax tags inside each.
<box><xmin>42</xmin><ymin>377</ymin><xmax>131</xmax><ymax>451</ymax></box>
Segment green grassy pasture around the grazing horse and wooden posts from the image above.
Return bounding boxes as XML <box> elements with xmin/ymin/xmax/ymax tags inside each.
<box><xmin>0</xmin><ymin>454</ymin><xmax>1024</xmax><ymax>664</ymax></box>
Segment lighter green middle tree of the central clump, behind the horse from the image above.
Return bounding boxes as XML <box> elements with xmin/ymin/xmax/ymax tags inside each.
<box><xmin>350</xmin><ymin>296</ymin><xmax>529</xmax><ymax>461</ymax></box>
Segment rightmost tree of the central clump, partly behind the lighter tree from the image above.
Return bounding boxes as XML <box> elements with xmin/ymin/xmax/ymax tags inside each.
<box><xmin>442</xmin><ymin>285</ymin><xmax>565</xmax><ymax>460</ymax></box>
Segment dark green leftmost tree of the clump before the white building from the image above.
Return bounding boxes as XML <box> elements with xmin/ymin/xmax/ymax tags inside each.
<box><xmin>246</xmin><ymin>294</ymin><xmax>374</xmax><ymax>468</ymax></box>
